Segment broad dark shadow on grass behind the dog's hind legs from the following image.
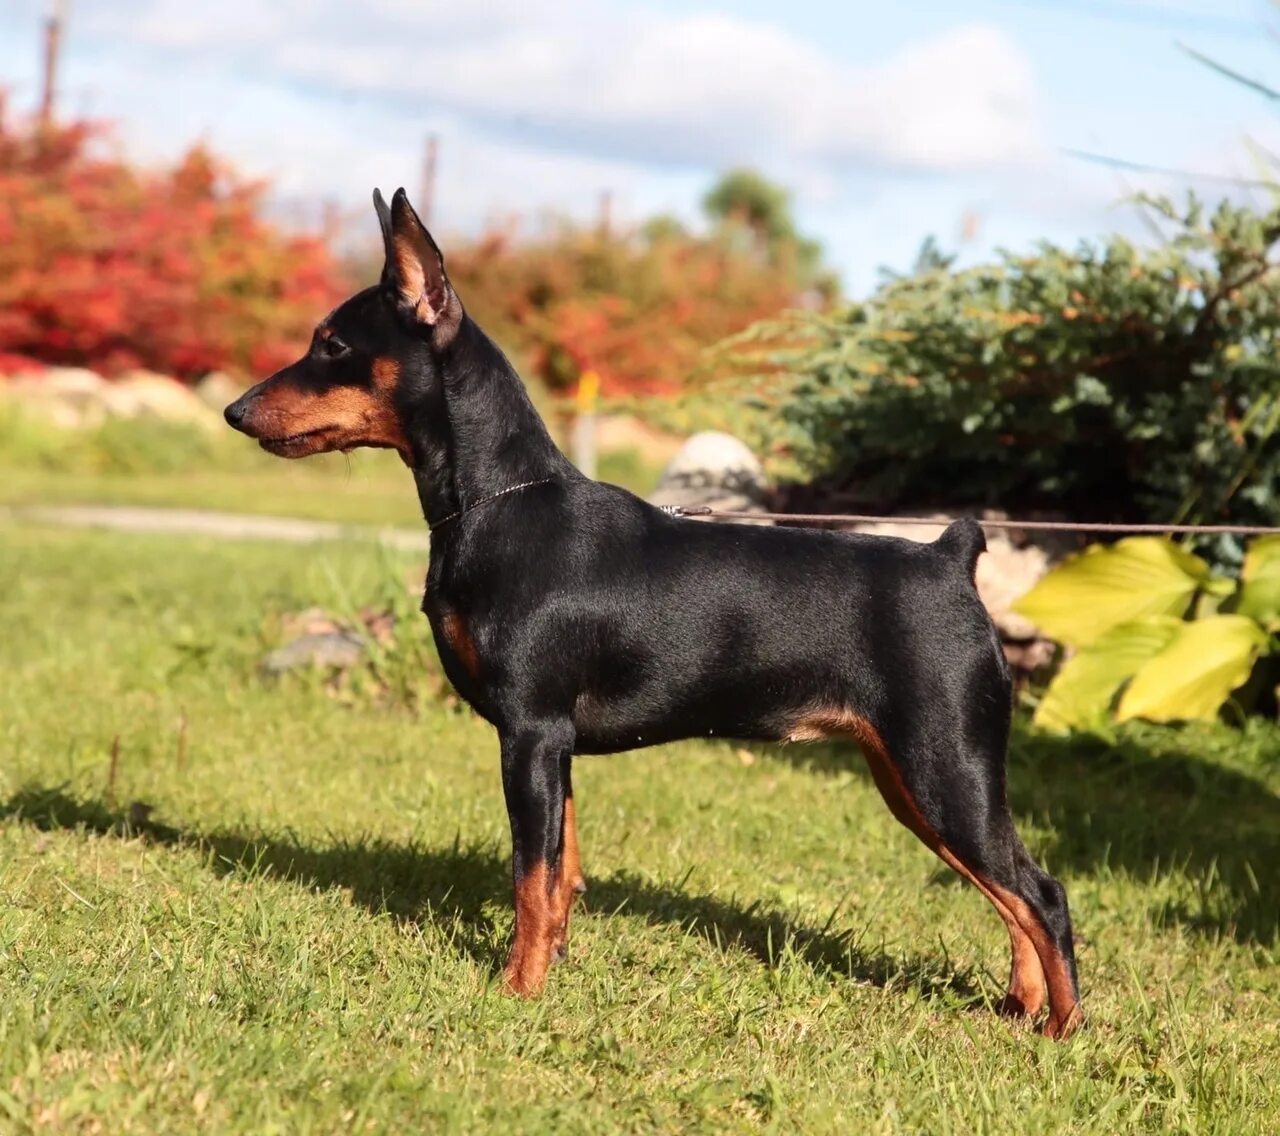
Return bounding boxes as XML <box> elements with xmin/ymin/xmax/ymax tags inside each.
<box><xmin>759</xmin><ymin>727</ymin><xmax>1280</xmax><ymax>945</ymax></box>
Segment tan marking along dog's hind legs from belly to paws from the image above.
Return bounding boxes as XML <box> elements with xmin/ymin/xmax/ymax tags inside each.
<box><xmin>788</xmin><ymin>709</ymin><xmax>1083</xmax><ymax>1037</ymax></box>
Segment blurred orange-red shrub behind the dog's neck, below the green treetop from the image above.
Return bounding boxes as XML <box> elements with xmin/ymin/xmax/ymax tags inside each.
<box><xmin>445</xmin><ymin>228</ymin><xmax>803</xmax><ymax>395</ymax></box>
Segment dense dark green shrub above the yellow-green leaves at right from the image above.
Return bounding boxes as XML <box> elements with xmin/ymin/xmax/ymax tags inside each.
<box><xmin>722</xmin><ymin>200</ymin><xmax>1280</xmax><ymax>523</ymax></box>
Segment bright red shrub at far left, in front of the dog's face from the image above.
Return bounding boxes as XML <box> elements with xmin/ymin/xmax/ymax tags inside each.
<box><xmin>0</xmin><ymin>100</ymin><xmax>343</xmax><ymax>377</ymax></box>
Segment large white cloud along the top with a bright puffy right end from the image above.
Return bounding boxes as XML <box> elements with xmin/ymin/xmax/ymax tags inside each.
<box><xmin>74</xmin><ymin>0</ymin><xmax>1039</xmax><ymax>171</ymax></box>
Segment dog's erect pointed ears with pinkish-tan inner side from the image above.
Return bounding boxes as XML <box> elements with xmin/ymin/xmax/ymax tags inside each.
<box><xmin>374</xmin><ymin>189</ymin><xmax>462</xmax><ymax>347</ymax></box>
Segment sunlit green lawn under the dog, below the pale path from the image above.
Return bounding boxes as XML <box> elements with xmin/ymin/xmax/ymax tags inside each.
<box><xmin>0</xmin><ymin>525</ymin><xmax>1280</xmax><ymax>1133</ymax></box>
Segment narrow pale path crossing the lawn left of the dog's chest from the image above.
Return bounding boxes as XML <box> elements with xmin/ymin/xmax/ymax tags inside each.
<box><xmin>0</xmin><ymin>505</ymin><xmax>428</xmax><ymax>551</ymax></box>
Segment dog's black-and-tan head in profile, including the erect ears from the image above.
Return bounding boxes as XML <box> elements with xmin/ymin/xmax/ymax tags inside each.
<box><xmin>225</xmin><ymin>189</ymin><xmax>463</xmax><ymax>464</ymax></box>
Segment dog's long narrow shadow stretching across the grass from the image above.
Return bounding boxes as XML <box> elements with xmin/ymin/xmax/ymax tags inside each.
<box><xmin>0</xmin><ymin>785</ymin><xmax>984</xmax><ymax>1007</ymax></box>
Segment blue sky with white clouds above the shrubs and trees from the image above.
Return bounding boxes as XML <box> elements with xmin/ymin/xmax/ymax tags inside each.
<box><xmin>0</xmin><ymin>0</ymin><xmax>1280</xmax><ymax>296</ymax></box>
